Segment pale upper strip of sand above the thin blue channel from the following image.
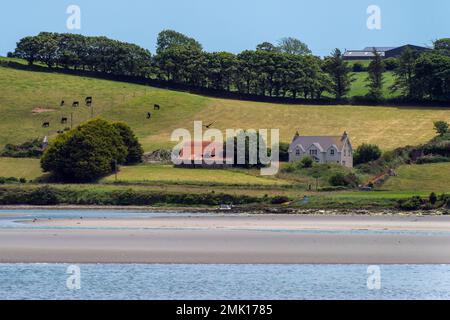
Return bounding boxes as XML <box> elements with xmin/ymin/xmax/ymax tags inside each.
<box><xmin>29</xmin><ymin>215</ymin><xmax>450</xmax><ymax>232</ymax></box>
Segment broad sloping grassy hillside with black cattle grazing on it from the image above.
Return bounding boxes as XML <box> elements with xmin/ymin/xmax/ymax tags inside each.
<box><xmin>0</xmin><ymin>67</ymin><xmax>450</xmax><ymax>151</ymax></box>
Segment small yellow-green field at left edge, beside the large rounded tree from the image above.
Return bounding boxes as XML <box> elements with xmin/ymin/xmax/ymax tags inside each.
<box><xmin>0</xmin><ymin>158</ymin><xmax>42</xmax><ymax>180</ymax></box>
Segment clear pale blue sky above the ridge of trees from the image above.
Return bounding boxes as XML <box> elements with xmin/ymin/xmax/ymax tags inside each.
<box><xmin>0</xmin><ymin>0</ymin><xmax>450</xmax><ymax>55</ymax></box>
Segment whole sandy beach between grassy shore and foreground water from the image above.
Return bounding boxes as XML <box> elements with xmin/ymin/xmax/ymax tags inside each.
<box><xmin>0</xmin><ymin>215</ymin><xmax>450</xmax><ymax>264</ymax></box>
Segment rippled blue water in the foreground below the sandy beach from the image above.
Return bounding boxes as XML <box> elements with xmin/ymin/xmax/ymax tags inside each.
<box><xmin>0</xmin><ymin>264</ymin><xmax>450</xmax><ymax>300</ymax></box>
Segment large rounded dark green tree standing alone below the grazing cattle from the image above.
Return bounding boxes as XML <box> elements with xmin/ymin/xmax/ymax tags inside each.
<box><xmin>41</xmin><ymin>119</ymin><xmax>127</xmax><ymax>182</ymax></box>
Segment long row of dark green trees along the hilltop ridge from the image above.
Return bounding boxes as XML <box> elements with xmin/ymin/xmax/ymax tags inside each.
<box><xmin>11</xmin><ymin>30</ymin><xmax>450</xmax><ymax>101</ymax></box>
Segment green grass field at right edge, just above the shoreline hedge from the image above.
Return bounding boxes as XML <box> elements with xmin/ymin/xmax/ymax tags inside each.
<box><xmin>382</xmin><ymin>163</ymin><xmax>450</xmax><ymax>192</ymax></box>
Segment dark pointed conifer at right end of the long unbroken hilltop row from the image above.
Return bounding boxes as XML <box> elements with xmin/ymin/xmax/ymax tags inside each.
<box><xmin>324</xmin><ymin>49</ymin><xmax>353</xmax><ymax>100</ymax></box>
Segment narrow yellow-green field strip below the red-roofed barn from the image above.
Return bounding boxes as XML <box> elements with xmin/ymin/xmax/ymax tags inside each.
<box><xmin>101</xmin><ymin>164</ymin><xmax>289</xmax><ymax>186</ymax></box>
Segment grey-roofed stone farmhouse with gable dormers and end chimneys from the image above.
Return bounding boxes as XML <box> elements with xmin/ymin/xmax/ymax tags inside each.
<box><xmin>289</xmin><ymin>132</ymin><xmax>353</xmax><ymax>168</ymax></box>
